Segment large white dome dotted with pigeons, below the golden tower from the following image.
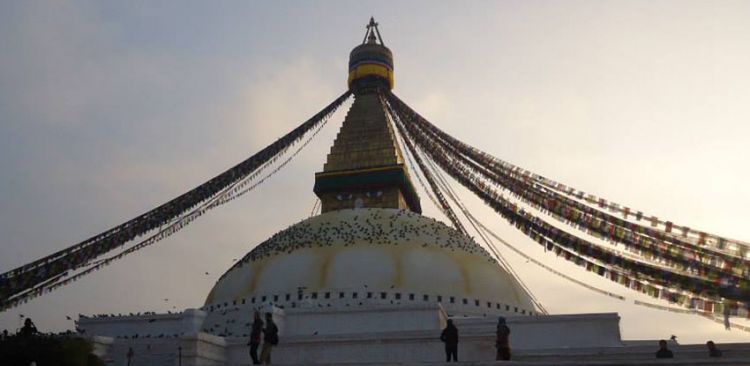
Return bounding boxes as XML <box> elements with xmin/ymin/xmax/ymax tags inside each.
<box><xmin>205</xmin><ymin>208</ymin><xmax>537</xmax><ymax>314</ymax></box>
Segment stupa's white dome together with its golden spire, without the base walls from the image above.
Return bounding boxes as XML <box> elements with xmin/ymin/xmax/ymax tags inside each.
<box><xmin>205</xmin><ymin>15</ymin><xmax>538</xmax><ymax>315</ymax></box>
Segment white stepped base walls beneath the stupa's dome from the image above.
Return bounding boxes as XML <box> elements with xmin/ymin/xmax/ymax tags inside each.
<box><xmin>79</xmin><ymin>304</ymin><xmax>623</xmax><ymax>366</ymax></box>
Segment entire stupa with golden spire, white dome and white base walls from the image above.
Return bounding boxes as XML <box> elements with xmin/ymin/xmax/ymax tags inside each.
<box><xmin>78</xmin><ymin>20</ymin><xmax>750</xmax><ymax>365</ymax></box>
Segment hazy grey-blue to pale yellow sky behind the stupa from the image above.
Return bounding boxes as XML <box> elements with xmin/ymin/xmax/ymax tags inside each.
<box><xmin>0</xmin><ymin>1</ymin><xmax>750</xmax><ymax>342</ymax></box>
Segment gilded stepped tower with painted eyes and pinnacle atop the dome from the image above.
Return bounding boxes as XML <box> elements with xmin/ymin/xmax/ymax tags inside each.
<box><xmin>314</xmin><ymin>19</ymin><xmax>421</xmax><ymax>213</ymax></box>
